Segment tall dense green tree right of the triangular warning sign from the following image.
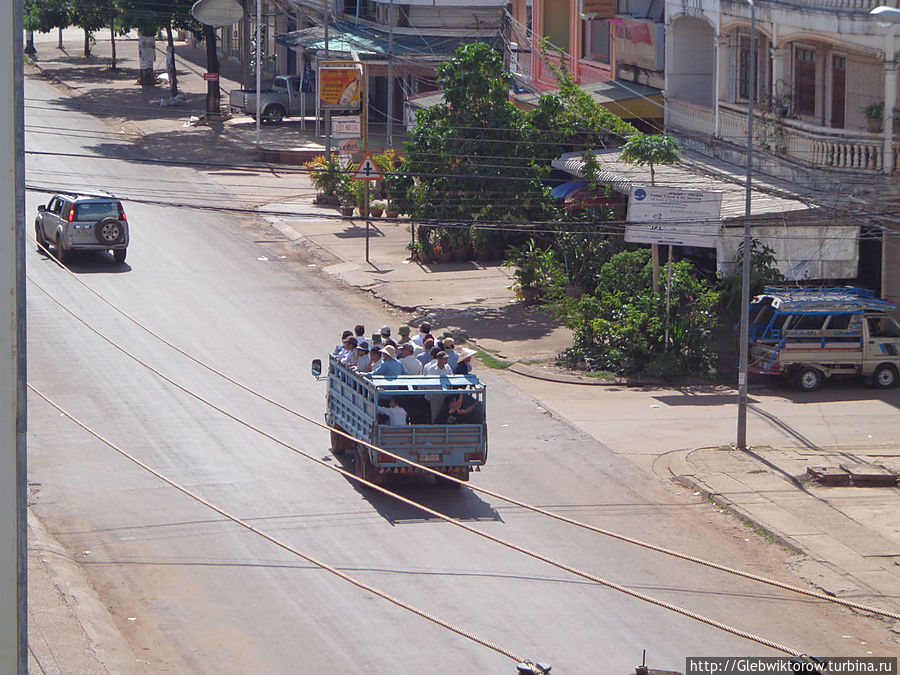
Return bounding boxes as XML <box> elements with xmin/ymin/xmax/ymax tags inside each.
<box><xmin>401</xmin><ymin>43</ymin><xmax>546</xmax><ymax>226</ymax></box>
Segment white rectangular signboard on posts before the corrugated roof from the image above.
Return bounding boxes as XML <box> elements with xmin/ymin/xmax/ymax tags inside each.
<box><xmin>625</xmin><ymin>187</ymin><xmax>722</xmax><ymax>248</ymax></box>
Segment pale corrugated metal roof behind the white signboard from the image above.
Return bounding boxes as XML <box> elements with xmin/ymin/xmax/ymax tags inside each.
<box><xmin>552</xmin><ymin>148</ymin><xmax>810</xmax><ymax>224</ymax></box>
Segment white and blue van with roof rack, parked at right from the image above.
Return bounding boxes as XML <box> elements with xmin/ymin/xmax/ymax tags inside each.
<box><xmin>749</xmin><ymin>287</ymin><xmax>900</xmax><ymax>391</ymax></box>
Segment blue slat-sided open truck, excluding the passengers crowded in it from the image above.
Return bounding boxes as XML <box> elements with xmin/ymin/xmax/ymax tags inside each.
<box><xmin>313</xmin><ymin>355</ymin><xmax>487</xmax><ymax>486</ymax></box>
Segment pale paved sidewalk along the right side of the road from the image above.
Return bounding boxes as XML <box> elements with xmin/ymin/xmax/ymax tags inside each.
<box><xmin>29</xmin><ymin>25</ymin><xmax>900</xmax><ymax>672</ymax></box>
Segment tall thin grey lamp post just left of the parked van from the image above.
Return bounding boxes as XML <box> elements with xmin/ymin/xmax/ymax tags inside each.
<box><xmin>737</xmin><ymin>0</ymin><xmax>756</xmax><ymax>450</ymax></box>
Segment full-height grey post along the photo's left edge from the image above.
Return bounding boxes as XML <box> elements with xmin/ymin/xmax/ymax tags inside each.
<box><xmin>0</xmin><ymin>0</ymin><xmax>28</xmax><ymax>675</ymax></box>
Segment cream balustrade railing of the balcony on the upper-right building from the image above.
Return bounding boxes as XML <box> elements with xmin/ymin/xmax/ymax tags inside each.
<box><xmin>666</xmin><ymin>98</ymin><xmax>900</xmax><ymax>173</ymax></box>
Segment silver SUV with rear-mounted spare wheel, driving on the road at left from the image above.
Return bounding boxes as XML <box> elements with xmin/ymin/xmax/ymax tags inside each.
<box><xmin>34</xmin><ymin>194</ymin><xmax>128</xmax><ymax>263</ymax></box>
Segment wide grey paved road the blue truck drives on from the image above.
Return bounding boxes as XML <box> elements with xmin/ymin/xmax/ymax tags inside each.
<box><xmin>27</xmin><ymin>67</ymin><xmax>890</xmax><ymax>673</ymax></box>
